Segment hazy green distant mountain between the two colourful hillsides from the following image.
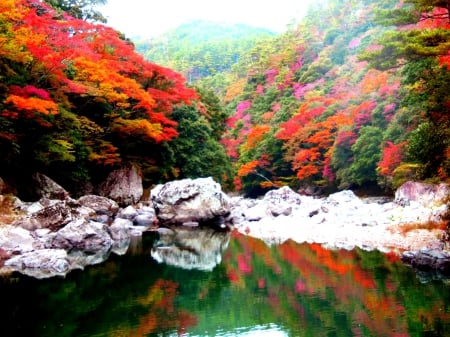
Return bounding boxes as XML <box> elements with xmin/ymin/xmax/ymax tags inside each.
<box><xmin>134</xmin><ymin>20</ymin><xmax>276</xmax><ymax>82</ymax></box>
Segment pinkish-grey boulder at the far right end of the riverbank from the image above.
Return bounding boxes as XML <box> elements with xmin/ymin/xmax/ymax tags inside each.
<box><xmin>394</xmin><ymin>181</ymin><xmax>450</xmax><ymax>207</ymax></box>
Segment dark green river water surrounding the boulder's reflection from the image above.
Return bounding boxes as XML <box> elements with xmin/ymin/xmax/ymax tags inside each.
<box><xmin>0</xmin><ymin>230</ymin><xmax>450</xmax><ymax>337</ymax></box>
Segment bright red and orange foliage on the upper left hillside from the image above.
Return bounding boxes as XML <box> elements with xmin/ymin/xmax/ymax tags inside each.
<box><xmin>0</xmin><ymin>0</ymin><xmax>197</xmax><ymax>151</ymax></box>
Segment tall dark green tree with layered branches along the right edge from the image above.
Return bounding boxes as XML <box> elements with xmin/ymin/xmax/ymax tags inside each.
<box><xmin>361</xmin><ymin>0</ymin><xmax>450</xmax><ymax>179</ymax></box>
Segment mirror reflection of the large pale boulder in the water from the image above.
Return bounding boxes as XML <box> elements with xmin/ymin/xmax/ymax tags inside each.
<box><xmin>151</xmin><ymin>227</ymin><xmax>230</xmax><ymax>271</ymax></box>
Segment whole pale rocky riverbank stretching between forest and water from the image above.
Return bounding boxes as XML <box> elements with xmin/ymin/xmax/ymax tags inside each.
<box><xmin>0</xmin><ymin>173</ymin><xmax>450</xmax><ymax>278</ymax></box>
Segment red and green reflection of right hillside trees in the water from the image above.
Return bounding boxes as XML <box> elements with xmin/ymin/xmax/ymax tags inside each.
<box><xmin>225</xmin><ymin>236</ymin><xmax>450</xmax><ymax>336</ymax></box>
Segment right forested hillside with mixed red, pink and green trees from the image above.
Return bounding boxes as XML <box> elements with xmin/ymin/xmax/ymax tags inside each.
<box><xmin>215</xmin><ymin>0</ymin><xmax>450</xmax><ymax>195</ymax></box>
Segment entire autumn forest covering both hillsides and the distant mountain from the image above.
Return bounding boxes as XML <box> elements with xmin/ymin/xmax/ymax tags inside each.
<box><xmin>0</xmin><ymin>0</ymin><xmax>450</xmax><ymax>195</ymax></box>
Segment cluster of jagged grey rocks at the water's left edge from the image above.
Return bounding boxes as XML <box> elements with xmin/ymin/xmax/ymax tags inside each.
<box><xmin>0</xmin><ymin>195</ymin><xmax>155</xmax><ymax>278</ymax></box>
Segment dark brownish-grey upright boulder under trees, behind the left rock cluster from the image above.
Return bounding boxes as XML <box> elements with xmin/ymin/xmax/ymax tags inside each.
<box><xmin>99</xmin><ymin>165</ymin><xmax>144</xmax><ymax>205</ymax></box>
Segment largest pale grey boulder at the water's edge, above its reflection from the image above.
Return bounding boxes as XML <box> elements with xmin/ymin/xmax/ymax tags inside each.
<box><xmin>150</xmin><ymin>177</ymin><xmax>230</xmax><ymax>224</ymax></box>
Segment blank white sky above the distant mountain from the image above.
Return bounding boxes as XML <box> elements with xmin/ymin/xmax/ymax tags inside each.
<box><xmin>99</xmin><ymin>0</ymin><xmax>317</xmax><ymax>37</ymax></box>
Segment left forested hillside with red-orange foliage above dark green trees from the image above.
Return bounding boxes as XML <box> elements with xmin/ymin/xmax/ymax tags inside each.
<box><xmin>0</xmin><ymin>0</ymin><xmax>230</xmax><ymax>197</ymax></box>
